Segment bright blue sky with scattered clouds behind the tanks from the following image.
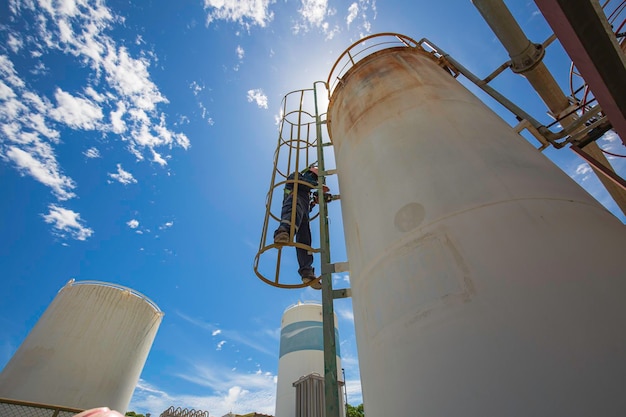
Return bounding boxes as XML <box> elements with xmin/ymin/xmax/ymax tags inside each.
<box><xmin>0</xmin><ymin>0</ymin><xmax>625</xmax><ymax>416</ymax></box>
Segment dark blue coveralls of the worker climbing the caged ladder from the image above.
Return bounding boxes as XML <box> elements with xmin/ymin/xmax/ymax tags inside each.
<box><xmin>274</xmin><ymin>169</ymin><xmax>317</xmax><ymax>277</ymax></box>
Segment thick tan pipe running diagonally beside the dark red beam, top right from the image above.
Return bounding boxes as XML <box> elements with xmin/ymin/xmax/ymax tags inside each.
<box><xmin>472</xmin><ymin>0</ymin><xmax>626</xmax><ymax>214</ymax></box>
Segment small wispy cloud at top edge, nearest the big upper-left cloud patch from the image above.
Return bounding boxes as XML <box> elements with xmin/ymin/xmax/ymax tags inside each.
<box><xmin>204</xmin><ymin>0</ymin><xmax>274</xmax><ymax>28</ymax></box>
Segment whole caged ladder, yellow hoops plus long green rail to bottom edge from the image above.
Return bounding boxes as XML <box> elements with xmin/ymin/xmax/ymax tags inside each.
<box><xmin>254</xmin><ymin>82</ymin><xmax>349</xmax><ymax>417</ymax></box>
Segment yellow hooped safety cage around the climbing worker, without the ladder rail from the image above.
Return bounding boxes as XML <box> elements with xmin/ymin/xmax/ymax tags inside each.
<box><xmin>254</xmin><ymin>88</ymin><xmax>332</xmax><ymax>288</ymax></box>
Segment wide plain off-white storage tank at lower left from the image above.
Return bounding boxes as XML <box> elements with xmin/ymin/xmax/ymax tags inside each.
<box><xmin>0</xmin><ymin>280</ymin><xmax>163</xmax><ymax>413</ymax></box>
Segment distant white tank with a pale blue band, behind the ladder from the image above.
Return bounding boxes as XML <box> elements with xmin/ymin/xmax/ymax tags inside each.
<box><xmin>275</xmin><ymin>303</ymin><xmax>345</xmax><ymax>417</ymax></box>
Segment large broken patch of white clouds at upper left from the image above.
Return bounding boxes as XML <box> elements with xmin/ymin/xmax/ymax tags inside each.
<box><xmin>0</xmin><ymin>1</ymin><xmax>190</xmax><ymax>221</ymax></box>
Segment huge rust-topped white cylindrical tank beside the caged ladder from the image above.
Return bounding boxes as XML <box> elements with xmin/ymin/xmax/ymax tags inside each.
<box><xmin>326</xmin><ymin>37</ymin><xmax>626</xmax><ymax>417</ymax></box>
